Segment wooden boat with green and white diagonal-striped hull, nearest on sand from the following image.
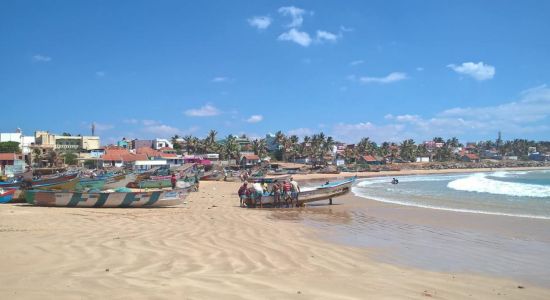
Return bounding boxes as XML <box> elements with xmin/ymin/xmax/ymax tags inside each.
<box><xmin>25</xmin><ymin>188</ymin><xmax>188</xmax><ymax>207</ymax></box>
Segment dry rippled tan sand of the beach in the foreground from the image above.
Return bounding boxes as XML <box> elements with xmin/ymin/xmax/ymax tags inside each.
<box><xmin>0</xmin><ymin>173</ymin><xmax>550</xmax><ymax>299</ymax></box>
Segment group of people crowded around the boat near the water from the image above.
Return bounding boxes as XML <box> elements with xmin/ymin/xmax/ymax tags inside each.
<box><xmin>238</xmin><ymin>178</ymin><xmax>300</xmax><ymax>207</ymax></box>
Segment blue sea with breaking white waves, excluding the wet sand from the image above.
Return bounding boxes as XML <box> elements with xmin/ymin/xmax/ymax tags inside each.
<box><xmin>352</xmin><ymin>170</ymin><xmax>550</xmax><ymax>219</ymax></box>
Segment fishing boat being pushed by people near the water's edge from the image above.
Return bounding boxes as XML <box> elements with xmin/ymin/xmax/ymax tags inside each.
<box><xmin>246</xmin><ymin>177</ymin><xmax>357</xmax><ymax>207</ymax></box>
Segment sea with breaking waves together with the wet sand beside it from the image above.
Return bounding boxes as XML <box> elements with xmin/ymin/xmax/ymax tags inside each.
<box><xmin>305</xmin><ymin>170</ymin><xmax>550</xmax><ymax>287</ymax></box>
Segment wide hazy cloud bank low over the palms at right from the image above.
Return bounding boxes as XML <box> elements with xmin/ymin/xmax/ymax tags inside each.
<box><xmin>333</xmin><ymin>85</ymin><xmax>550</xmax><ymax>142</ymax></box>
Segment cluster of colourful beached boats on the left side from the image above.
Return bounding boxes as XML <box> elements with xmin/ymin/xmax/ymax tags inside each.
<box><xmin>0</xmin><ymin>169</ymin><xmax>196</xmax><ymax>207</ymax></box>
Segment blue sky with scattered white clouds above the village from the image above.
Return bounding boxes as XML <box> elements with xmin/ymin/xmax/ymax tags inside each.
<box><xmin>0</xmin><ymin>0</ymin><xmax>550</xmax><ymax>143</ymax></box>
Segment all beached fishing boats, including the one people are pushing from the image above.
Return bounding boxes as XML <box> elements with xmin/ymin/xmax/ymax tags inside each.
<box><xmin>0</xmin><ymin>166</ymin><xmax>355</xmax><ymax>207</ymax></box>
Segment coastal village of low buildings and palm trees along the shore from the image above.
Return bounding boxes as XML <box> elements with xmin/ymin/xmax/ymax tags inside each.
<box><xmin>0</xmin><ymin>128</ymin><xmax>550</xmax><ymax>177</ymax></box>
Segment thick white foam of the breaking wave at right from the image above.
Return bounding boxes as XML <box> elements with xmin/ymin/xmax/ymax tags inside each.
<box><xmin>447</xmin><ymin>173</ymin><xmax>550</xmax><ymax>198</ymax></box>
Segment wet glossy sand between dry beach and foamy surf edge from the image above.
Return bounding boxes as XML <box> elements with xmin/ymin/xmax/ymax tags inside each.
<box><xmin>306</xmin><ymin>194</ymin><xmax>550</xmax><ymax>288</ymax></box>
